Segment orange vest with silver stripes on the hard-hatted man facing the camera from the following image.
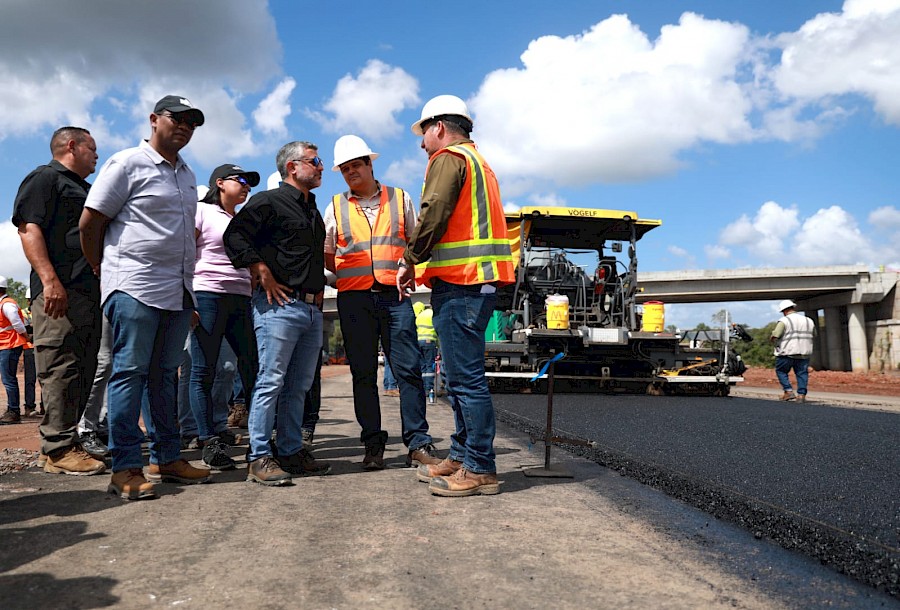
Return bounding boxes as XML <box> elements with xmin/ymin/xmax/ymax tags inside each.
<box><xmin>331</xmin><ymin>186</ymin><xmax>407</xmax><ymax>291</ymax></box>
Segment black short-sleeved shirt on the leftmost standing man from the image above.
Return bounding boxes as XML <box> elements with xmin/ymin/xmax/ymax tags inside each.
<box><xmin>12</xmin><ymin>159</ymin><xmax>94</xmax><ymax>299</ymax></box>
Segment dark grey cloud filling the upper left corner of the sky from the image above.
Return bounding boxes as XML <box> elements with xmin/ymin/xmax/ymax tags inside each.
<box><xmin>0</xmin><ymin>0</ymin><xmax>281</xmax><ymax>141</ymax></box>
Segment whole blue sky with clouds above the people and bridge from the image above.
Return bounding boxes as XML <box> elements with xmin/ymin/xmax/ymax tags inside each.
<box><xmin>0</xmin><ymin>0</ymin><xmax>900</xmax><ymax>328</ymax></box>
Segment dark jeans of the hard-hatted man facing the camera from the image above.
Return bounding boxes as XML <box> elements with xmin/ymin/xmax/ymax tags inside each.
<box><xmin>338</xmin><ymin>289</ymin><xmax>432</xmax><ymax>450</ymax></box>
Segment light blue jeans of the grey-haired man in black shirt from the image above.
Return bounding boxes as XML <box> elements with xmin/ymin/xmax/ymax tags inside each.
<box><xmin>248</xmin><ymin>289</ymin><xmax>322</xmax><ymax>461</ymax></box>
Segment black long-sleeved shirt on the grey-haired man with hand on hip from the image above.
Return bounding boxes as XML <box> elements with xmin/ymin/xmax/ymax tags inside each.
<box><xmin>223</xmin><ymin>183</ymin><xmax>325</xmax><ymax>293</ymax></box>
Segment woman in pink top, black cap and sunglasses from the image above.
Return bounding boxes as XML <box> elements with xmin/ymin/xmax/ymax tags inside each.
<box><xmin>190</xmin><ymin>163</ymin><xmax>259</xmax><ymax>470</ymax></box>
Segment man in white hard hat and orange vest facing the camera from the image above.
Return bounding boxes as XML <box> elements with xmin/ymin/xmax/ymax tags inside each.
<box><xmin>324</xmin><ymin>135</ymin><xmax>441</xmax><ymax>470</ymax></box>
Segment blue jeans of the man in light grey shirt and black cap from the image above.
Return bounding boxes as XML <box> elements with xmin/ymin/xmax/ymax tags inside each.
<box><xmin>104</xmin><ymin>291</ymin><xmax>191</xmax><ymax>472</ymax></box>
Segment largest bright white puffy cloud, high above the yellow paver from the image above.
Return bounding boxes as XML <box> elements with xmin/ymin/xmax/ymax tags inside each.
<box><xmin>469</xmin><ymin>13</ymin><xmax>753</xmax><ymax>184</ymax></box>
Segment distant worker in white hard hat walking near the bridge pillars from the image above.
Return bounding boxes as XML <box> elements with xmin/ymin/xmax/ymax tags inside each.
<box><xmin>769</xmin><ymin>299</ymin><xmax>816</xmax><ymax>402</ymax></box>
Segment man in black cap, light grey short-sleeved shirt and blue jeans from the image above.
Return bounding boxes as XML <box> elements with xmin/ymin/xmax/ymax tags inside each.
<box><xmin>79</xmin><ymin>95</ymin><xmax>209</xmax><ymax>500</ymax></box>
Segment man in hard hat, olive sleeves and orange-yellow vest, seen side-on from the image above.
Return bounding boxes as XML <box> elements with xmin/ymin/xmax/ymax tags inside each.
<box><xmin>397</xmin><ymin>95</ymin><xmax>515</xmax><ymax>496</ymax></box>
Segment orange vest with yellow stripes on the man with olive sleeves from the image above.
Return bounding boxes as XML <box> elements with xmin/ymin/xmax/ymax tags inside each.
<box><xmin>416</xmin><ymin>143</ymin><xmax>516</xmax><ymax>287</ymax></box>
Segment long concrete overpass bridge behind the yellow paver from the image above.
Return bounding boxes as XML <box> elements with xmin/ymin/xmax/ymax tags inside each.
<box><xmin>324</xmin><ymin>265</ymin><xmax>900</xmax><ymax>372</ymax></box>
